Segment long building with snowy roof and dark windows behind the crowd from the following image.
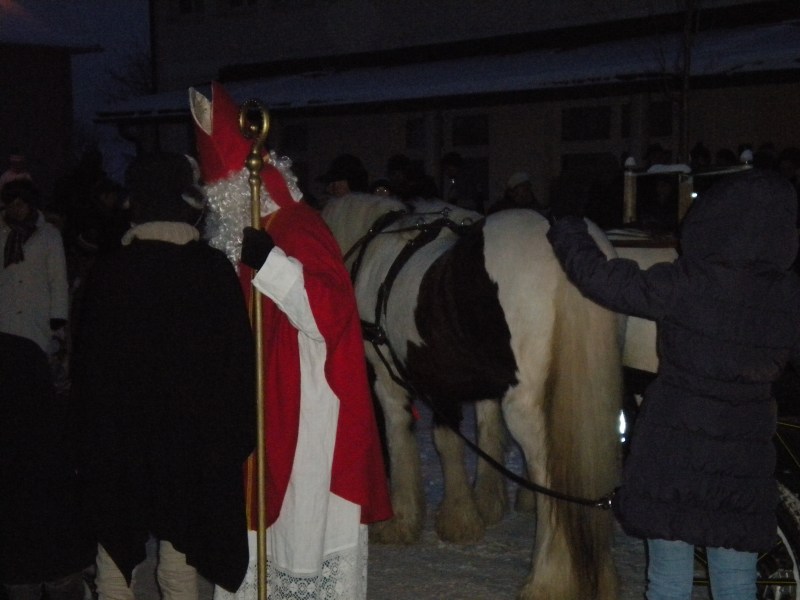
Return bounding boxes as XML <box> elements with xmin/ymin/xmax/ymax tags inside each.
<box><xmin>103</xmin><ymin>0</ymin><xmax>800</xmax><ymax>211</ymax></box>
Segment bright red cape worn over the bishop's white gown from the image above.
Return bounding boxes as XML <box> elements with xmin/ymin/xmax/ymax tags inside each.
<box><xmin>240</xmin><ymin>202</ymin><xmax>392</xmax><ymax>529</ymax></box>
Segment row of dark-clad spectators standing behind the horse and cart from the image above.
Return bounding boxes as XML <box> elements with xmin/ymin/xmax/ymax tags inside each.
<box><xmin>314</xmin><ymin>142</ymin><xmax>800</xmax><ymax>241</ymax></box>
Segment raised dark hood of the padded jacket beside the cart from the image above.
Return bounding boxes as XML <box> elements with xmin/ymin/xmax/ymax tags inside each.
<box><xmin>681</xmin><ymin>169</ymin><xmax>798</xmax><ymax>270</ymax></box>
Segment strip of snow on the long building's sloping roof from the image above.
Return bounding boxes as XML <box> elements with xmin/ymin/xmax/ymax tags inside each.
<box><xmin>97</xmin><ymin>21</ymin><xmax>800</xmax><ymax>122</ymax></box>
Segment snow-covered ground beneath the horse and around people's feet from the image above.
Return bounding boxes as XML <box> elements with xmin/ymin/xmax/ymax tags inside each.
<box><xmin>128</xmin><ymin>398</ymin><xmax>708</xmax><ymax>600</ymax></box>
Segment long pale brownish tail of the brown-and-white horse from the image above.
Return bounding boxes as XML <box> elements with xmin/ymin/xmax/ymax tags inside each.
<box><xmin>545</xmin><ymin>260</ymin><xmax>622</xmax><ymax>598</ymax></box>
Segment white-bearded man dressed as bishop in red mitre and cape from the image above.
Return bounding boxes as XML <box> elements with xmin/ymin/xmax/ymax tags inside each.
<box><xmin>190</xmin><ymin>84</ymin><xmax>392</xmax><ymax>600</ymax></box>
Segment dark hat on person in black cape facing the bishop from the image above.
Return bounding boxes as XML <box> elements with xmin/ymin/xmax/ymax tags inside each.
<box><xmin>125</xmin><ymin>152</ymin><xmax>206</xmax><ymax>224</ymax></box>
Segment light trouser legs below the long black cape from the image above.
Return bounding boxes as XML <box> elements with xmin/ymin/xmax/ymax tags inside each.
<box><xmin>95</xmin><ymin>540</ymin><xmax>198</xmax><ymax>600</ymax></box>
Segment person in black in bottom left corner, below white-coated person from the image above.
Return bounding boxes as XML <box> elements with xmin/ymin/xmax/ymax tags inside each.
<box><xmin>0</xmin><ymin>332</ymin><xmax>94</xmax><ymax>600</ymax></box>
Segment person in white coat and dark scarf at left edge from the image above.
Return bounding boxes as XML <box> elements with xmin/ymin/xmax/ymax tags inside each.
<box><xmin>0</xmin><ymin>180</ymin><xmax>69</xmax><ymax>353</ymax></box>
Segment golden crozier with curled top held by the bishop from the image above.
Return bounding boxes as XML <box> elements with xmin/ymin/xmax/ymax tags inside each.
<box><xmin>239</xmin><ymin>100</ymin><xmax>269</xmax><ymax>600</ymax></box>
